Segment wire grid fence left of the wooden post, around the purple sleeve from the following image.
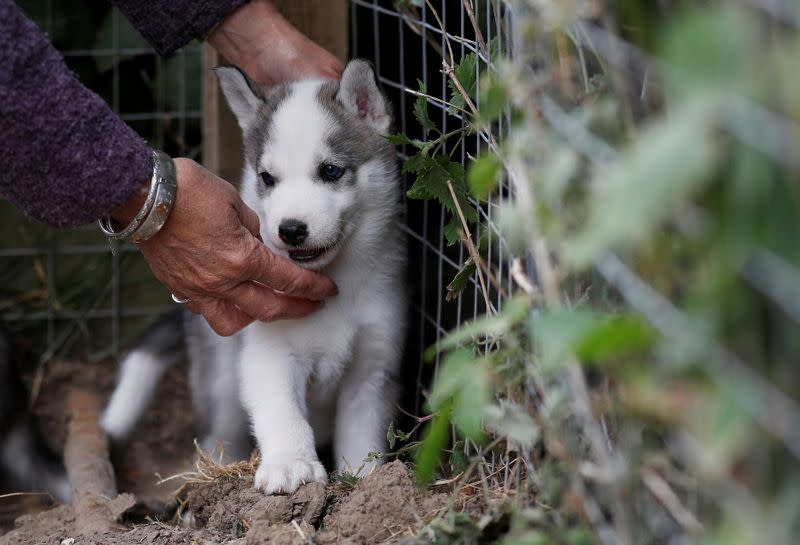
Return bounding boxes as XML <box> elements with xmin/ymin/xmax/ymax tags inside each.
<box><xmin>0</xmin><ymin>4</ymin><xmax>202</xmax><ymax>362</ymax></box>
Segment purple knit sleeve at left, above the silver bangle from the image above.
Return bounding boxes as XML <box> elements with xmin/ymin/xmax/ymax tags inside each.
<box><xmin>0</xmin><ymin>0</ymin><xmax>153</xmax><ymax>227</ymax></box>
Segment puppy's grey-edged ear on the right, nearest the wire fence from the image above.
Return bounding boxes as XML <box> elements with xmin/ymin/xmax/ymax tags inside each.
<box><xmin>336</xmin><ymin>59</ymin><xmax>392</xmax><ymax>135</ymax></box>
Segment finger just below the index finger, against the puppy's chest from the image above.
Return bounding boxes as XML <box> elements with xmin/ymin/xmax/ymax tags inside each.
<box><xmin>227</xmin><ymin>282</ymin><xmax>322</xmax><ymax>322</ymax></box>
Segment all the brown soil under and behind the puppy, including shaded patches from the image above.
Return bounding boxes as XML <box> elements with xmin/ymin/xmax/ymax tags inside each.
<box><xmin>0</xmin><ymin>362</ymin><xmax>447</xmax><ymax>545</ymax></box>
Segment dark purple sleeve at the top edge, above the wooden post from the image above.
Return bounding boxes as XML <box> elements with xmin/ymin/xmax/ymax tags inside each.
<box><xmin>111</xmin><ymin>0</ymin><xmax>248</xmax><ymax>55</ymax></box>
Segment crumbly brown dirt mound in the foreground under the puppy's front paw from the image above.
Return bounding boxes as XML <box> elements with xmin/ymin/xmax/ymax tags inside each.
<box><xmin>0</xmin><ymin>462</ymin><xmax>446</xmax><ymax>545</ymax></box>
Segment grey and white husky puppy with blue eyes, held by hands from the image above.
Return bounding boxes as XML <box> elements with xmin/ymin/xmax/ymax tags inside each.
<box><xmin>102</xmin><ymin>60</ymin><xmax>405</xmax><ymax>493</ymax></box>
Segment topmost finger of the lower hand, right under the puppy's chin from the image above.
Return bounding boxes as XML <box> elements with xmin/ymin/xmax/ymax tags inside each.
<box><xmin>248</xmin><ymin>244</ymin><xmax>339</xmax><ymax>301</ymax></box>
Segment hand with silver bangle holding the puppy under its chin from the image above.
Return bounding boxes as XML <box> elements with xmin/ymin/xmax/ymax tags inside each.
<box><xmin>123</xmin><ymin>159</ymin><xmax>336</xmax><ymax>335</ymax></box>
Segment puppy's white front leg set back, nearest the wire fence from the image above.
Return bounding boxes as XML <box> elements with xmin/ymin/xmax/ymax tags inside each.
<box><xmin>334</xmin><ymin>328</ymin><xmax>402</xmax><ymax>475</ymax></box>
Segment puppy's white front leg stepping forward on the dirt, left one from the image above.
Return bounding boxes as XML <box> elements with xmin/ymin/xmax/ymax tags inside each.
<box><xmin>241</xmin><ymin>336</ymin><xmax>328</xmax><ymax>494</ymax></box>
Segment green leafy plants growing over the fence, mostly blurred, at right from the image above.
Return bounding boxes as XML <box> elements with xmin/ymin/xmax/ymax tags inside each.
<box><xmin>392</xmin><ymin>1</ymin><xmax>800</xmax><ymax>544</ymax></box>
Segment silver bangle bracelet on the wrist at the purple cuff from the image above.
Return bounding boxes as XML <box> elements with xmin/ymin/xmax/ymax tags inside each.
<box><xmin>98</xmin><ymin>150</ymin><xmax>178</xmax><ymax>243</ymax></box>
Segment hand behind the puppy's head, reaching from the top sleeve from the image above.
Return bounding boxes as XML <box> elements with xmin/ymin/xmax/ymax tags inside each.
<box><xmin>206</xmin><ymin>0</ymin><xmax>343</xmax><ymax>85</ymax></box>
